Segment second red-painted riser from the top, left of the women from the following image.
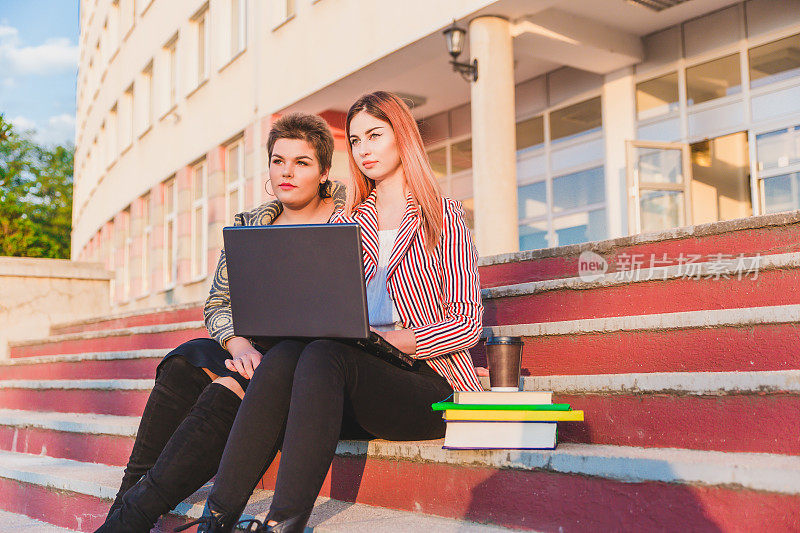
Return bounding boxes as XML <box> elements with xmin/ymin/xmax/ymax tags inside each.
<box><xmin>9</xmin><ymin>327</ymin><xmax>208</xmax><ymax>357</ymax></box>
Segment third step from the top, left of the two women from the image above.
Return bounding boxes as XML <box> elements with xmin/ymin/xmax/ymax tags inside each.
<box><xmin>0</xmin><ymin>348</ymin><xmax>162</xmax><ymax>380</ymax></box>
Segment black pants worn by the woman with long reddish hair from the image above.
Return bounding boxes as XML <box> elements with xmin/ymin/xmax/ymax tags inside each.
<box><xmin>209</xmin><ymin>340</ymin><xmax>453</xmax><ymax>521</ymax></box>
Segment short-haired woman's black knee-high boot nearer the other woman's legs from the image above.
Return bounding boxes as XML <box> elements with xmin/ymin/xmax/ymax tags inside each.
<box><xmin>96</xmin><ymin>383</ymin><xmax>241</xmax><ymax>533</ymax></box>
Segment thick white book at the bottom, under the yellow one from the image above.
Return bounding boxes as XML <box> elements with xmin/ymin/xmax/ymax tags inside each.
<box><xmin>444</xmin><ymin>422</ymin><xmax>558</xmax><ymax>450</ymax></box>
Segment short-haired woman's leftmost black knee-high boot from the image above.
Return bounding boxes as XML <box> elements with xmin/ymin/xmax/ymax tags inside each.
<box><xmin>108</xmin><ymin>355</ymin><xmax>211</xmax><ymax>516</ymax></box>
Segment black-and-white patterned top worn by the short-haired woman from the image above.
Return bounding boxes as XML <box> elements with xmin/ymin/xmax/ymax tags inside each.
<box><xmin>203</xmin><ymin>180</ymin><xmax>347</xmax><ymax>348</ymax></box>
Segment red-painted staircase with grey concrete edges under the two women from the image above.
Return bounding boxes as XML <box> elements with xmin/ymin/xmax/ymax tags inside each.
<box><xmin>0</xmin><ymin>212</ymin><xmax>800</xmax><ymax>532</ymax></box>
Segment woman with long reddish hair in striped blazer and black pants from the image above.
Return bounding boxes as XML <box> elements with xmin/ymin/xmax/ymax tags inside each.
<box><xmin>188</xmin><ymin>92</ymin><xmax>483</xmax><ymax>532</ymax></box>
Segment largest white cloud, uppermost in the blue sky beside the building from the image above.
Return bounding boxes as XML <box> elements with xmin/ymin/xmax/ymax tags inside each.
<box><xmin>0</xmin><ymin>25</ymin><xmax>78</xmax><ymax>75</ymax></box>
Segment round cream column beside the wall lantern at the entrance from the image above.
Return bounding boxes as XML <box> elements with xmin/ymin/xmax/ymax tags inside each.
<box><xmin>469</xmin><ymin>16</ymin><xmax>519</xmax><ymax>256</ymax></box>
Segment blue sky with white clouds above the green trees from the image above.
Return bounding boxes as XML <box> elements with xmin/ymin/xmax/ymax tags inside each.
<box><xmin>0</xmin><ymin>0</ymin><xmax>80</xmax><ymax>144</ymax></box>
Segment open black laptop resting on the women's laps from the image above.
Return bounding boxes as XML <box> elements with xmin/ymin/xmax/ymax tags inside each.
<box><xmin>222</xmin><ymin>224</ymin><xmax>417</xmax><ymax>369</ymax></box>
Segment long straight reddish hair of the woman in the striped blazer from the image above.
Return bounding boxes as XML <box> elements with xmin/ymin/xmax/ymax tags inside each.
<box><xmin>345</xmin><ymin>91</ymin><xmax>443</xmax><ymax>252</ymax></box>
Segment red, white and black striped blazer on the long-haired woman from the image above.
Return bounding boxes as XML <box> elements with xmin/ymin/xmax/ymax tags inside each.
<box><xmin>331</xmin><ymin>191</ymin><xmax>483</xmax><ymax>391</ymax></box>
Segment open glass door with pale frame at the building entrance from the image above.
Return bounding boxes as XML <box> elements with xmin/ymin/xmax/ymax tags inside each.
<box><xmin>626</xmin><ymin>141</ymin><xmax>692</xmax><ymax>234</ymax></box>
